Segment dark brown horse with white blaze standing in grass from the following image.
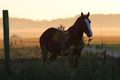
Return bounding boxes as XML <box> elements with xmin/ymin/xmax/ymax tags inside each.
<box><xmin>39</xmin><ymin>12</ymin><xmax>93</xmax><ymax>65</ymax></box>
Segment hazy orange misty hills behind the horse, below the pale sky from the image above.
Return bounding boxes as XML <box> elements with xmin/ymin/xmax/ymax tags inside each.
<box><xmin>0</xmin><ymin>14</ymin><xmax>120</xmax><ymax>38</ymax></box>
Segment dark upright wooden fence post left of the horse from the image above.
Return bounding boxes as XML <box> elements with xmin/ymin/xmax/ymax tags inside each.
<box><xmin>3</xmin><ymin>10</ymin><xmax>10</xmax><ymax>74</ymax></box>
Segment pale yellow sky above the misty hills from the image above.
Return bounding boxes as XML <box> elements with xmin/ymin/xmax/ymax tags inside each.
<box><xmin>0</xmin><ymin>0</ymin><xmax>120</xmax><ymax>20</ymax></box>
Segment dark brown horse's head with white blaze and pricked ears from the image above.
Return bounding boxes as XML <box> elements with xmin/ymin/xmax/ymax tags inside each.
<box><xmin>76</xmin><ymin>12</ymin><xmax>92</xmax><ymax>37</ymax></box>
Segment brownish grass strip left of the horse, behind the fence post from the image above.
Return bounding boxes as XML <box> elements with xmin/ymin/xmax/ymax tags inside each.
<box><xmin>0</xmin><ymin>46</ymin><xmax>41</xmax><ymax>59</ymax></box>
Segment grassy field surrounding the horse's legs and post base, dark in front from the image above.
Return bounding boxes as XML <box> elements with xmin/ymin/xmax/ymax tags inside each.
<box><xmin>0</xmin><ymin>44</ymin><xmax>120</xmax><ymax>80</ymax></box>
